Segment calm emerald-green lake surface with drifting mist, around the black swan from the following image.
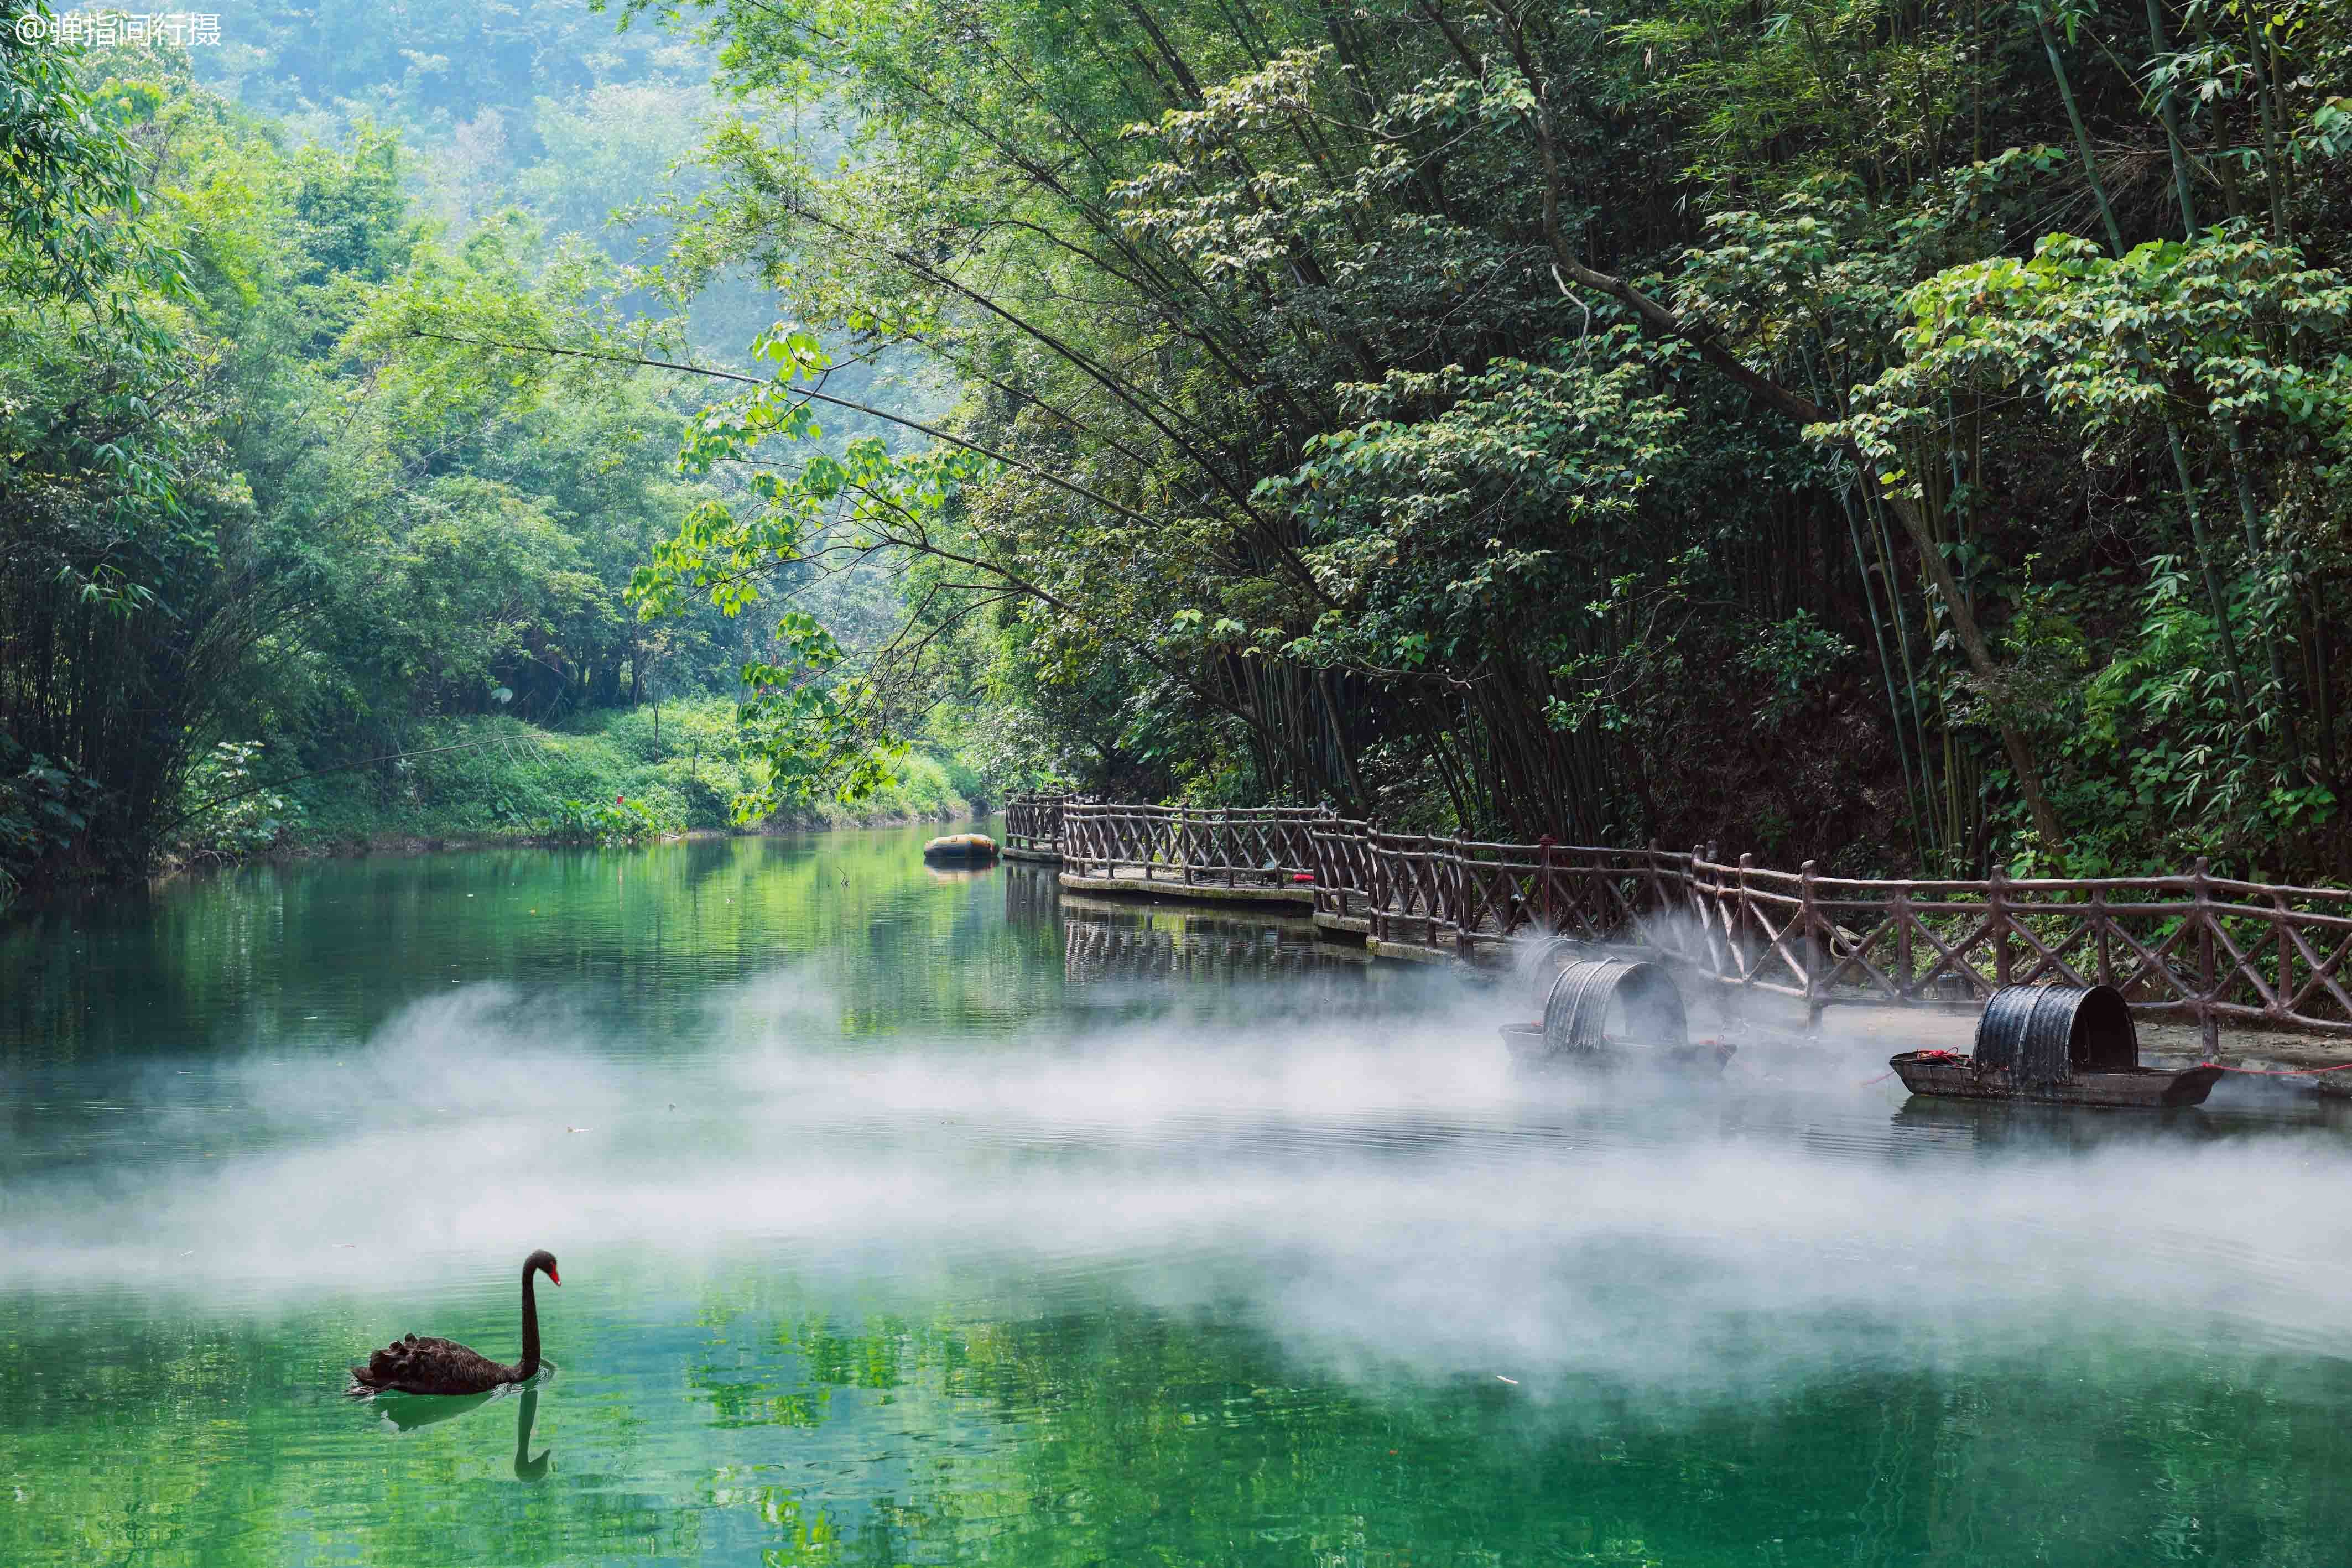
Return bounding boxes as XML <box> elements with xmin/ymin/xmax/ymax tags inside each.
<box><xmin>0</xmin><ymin>830</ymin><xmax>2352</xmax><ymax>1568</ymax></box>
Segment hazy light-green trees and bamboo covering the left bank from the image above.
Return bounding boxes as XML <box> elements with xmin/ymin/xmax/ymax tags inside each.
<box><xmin>0</xmin><ymin>5</ymin><xmax>936</xmax><ymax>895</ymax></box>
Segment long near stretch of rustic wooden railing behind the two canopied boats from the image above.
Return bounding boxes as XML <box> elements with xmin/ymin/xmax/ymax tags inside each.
<box><xmin>1373</xmin><ymin>832</ymin><xmax>2352</xmax><ymax>1036</ymax></box>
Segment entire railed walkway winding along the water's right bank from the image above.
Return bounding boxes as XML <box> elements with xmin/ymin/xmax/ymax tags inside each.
<box><xmin>1005</xmin><ymin>795</ymin><xmax>2352</xmax><ymax>1077</ymax></box>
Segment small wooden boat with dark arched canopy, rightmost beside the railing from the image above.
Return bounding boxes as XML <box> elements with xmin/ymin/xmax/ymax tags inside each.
<box><xmin>1886</xmin><ymin>985</ymin><xmax>2223</xmax><ymax>1109</ymax></box>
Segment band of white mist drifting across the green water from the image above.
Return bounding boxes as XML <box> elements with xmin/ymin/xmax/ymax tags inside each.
<box><xmin>0</xmin><ymin>971</ymin><xmax>2352</xmax><ymax>1399</ymax></box>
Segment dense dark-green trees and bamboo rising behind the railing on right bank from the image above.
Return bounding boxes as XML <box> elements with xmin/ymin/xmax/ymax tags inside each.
<box><xmin>602</xmin><ymin>0</ymin><xmax>2352</xmax><ymax>874</ymax></box>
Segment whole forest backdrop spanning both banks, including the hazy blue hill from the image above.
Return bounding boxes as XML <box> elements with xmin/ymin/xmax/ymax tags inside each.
<box><xmin>0</xmin><ymin>0</ymin><xmax>2352</xmax><ymax>879</ymax></box>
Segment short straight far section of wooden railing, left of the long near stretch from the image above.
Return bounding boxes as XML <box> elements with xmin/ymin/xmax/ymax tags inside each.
<box><xmin>1061</xmin><ymin>801</ymin><xmax>1331</xmax><ymax>886</ymax></box>
